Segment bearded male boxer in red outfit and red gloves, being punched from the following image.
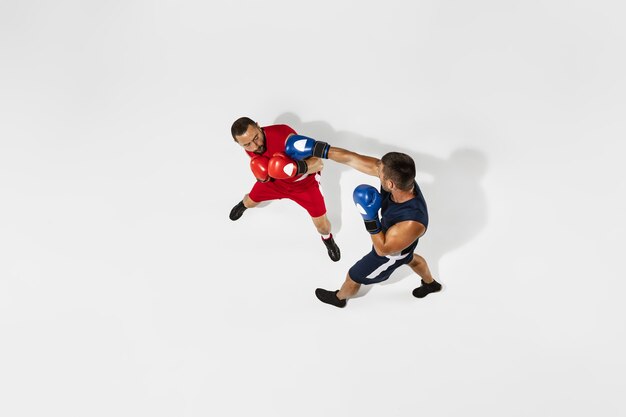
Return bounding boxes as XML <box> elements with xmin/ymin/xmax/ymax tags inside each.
<box><xmin>230</xmin><ymin>117</ymin><xmax>341</xmax><ymax>262</ymax></box>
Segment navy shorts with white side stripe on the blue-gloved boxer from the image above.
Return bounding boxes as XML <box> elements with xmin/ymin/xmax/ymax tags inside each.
<box><xmin>348</xmin><ymin>248</ymin><xmax>413</xmax><ymax>285</ymax></box>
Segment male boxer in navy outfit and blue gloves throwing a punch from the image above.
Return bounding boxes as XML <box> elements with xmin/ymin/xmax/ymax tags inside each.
<box><xmin>285</xmin><ymin>135</ymin><xmax>441</xmax><ymax>307</ymax></box>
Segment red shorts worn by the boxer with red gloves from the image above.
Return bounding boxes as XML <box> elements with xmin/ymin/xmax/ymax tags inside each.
<box><xmin>249</xmin><ymin>173</ymin><xmax>326</xmax><ymax>217</ymax></box>
